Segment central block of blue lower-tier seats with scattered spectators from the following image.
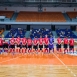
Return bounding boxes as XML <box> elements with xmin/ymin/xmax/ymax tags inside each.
<box><xmin>30</xmin><ymin>28</ymin><xmax>53</xmax><ymax>39</ymax></box>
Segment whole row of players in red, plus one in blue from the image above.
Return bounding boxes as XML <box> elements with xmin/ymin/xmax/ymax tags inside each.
<box><xmin>0</xmin><ymin>35</ymin><xmax>74</xmax><ymax>52</ymax></box>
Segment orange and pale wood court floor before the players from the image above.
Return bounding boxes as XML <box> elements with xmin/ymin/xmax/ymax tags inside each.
<box><xmin>0</xmin><ymin>50</ymin><xmax>77</xmax><ymax>77</ymax></box>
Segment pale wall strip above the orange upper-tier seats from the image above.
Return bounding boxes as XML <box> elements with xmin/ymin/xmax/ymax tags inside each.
<box><xmin>0</xmin><ymin>6</ymin><xmax>77</xmax><ymax>12</ymax></box>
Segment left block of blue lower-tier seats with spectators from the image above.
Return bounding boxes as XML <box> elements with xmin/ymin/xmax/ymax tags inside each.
<box><xmin>5</xmin><ymin>28</ymin><xmax>26</xmax><ymax>38</ymax></box>
